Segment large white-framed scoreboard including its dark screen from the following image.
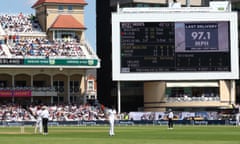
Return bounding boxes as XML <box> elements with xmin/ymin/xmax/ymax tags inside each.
<box><xmin>112</xmin><ymin>12</ymin><xmax>238</xmax><ymax>80</ymax></box>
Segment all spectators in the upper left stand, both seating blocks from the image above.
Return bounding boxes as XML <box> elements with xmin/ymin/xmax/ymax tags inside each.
<box><xmin>0</xmin><ymin>13</ymin><xmax>93</xmax><ymax>58</ymax></box>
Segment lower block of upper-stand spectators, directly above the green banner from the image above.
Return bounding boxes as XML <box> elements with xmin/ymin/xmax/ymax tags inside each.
<box><xmin>10</xmin><ymin>38</ymin><xmax>86</xmax><ymax>58</ymax></box>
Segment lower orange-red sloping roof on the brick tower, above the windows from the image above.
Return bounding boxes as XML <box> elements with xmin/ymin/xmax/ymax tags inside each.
<box><xmin>50</xmin><ymin>15</ymin><xmax>86</xmax><ymax>29</ymax></box>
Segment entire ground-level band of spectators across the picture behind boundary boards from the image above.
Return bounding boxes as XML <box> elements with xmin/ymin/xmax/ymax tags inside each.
<box><xmin>0</xmin><ymin>103</ymin><xmax>240</xmax><ymax>122</ymax></box>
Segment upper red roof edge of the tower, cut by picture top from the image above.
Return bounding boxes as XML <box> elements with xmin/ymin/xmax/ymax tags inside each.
<box><xmin>32</xmin><ymin>0</ymin><xmax>87</xmax><ymax>8</ymax></box>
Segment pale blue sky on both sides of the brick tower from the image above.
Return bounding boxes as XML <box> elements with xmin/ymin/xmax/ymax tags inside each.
<box><xmin>0</xmin><ymin>0</ymin><xmax>96</xmax><ymax>51</ymax></box>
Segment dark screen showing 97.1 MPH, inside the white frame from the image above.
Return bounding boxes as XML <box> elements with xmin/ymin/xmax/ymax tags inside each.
<box><xmin>120</xmin><ymin>22</ymin><xmax>231</xmax><ymax>73</ymax></box>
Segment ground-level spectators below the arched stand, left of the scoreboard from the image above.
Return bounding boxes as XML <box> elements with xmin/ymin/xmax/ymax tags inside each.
<box><xmin>0</xmin><ymin>104</ymin><xmax>106</xmax><ymax>121</ymax></box>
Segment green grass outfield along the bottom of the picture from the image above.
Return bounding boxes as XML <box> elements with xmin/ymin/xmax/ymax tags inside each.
<box><xmin>0</xmin><ymin>125</ymin><xmax>240</xmax><ymax>144</ymax></box>
